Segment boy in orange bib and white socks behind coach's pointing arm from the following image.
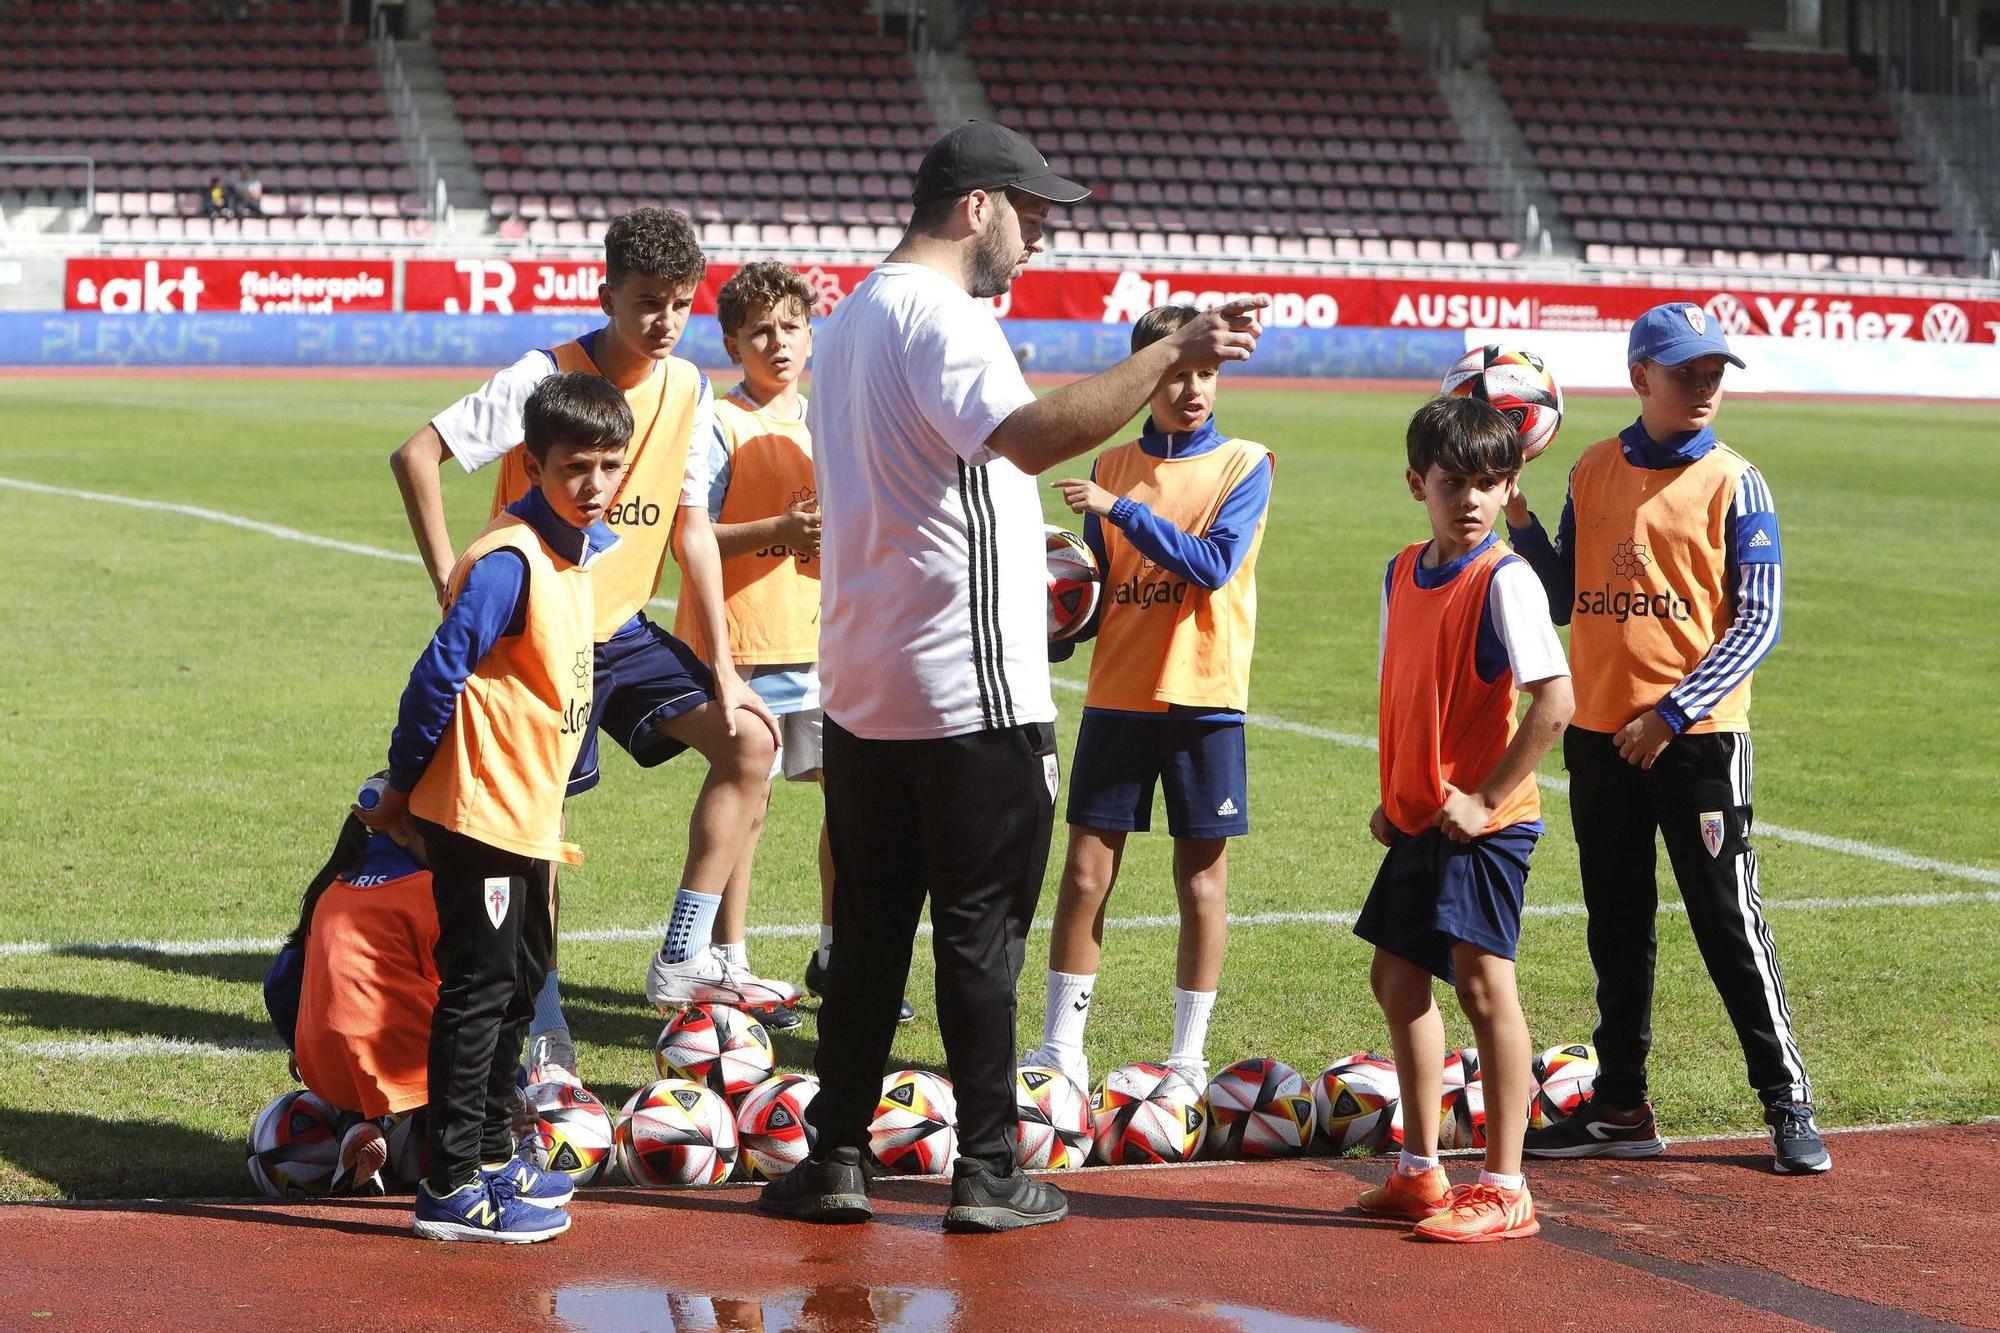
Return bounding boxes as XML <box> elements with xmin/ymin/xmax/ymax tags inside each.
<box><xmin>1028</xmin><ymin>306</ymin><xmax>1274</xmax><ymax>1093</ymax></box>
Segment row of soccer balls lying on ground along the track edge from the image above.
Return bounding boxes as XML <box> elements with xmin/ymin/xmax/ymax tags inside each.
<box><xmin>250</xmin><ymin>1005</ymin><xmax>1598</xmax><ymax>1199</ymax></box>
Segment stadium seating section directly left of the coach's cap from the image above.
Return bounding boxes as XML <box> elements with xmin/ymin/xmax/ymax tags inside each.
<box><xmin>432</xmin><ymin>0</ymin><xmax>934</xmax><ymax>246</ymax></box>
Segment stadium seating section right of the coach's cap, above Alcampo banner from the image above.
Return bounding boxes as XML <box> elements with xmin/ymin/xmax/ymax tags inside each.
<box><xmin>968</xmin><ymin>0</ymin><xmax>1518</xmax><ymax>260</ymax></box>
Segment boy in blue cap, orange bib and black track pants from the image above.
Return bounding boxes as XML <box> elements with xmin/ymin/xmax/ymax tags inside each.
<box><xmin>1508</xmin><ymin>302</ymin><xmax>1832</xmax><ymax>1175</ymax></box>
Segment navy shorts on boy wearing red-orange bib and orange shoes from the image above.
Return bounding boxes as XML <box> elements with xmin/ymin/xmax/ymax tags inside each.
<box><xmin>1354</xmin><ymin>825</ymin><xmax>1542</xmax><ymax>983</ymax></box>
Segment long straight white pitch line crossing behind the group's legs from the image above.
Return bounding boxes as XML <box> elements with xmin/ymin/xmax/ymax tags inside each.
<box><xmin>0</xmin><ymin>889</ymin><xmax>2000</xmax><ymax>959</ymax></box>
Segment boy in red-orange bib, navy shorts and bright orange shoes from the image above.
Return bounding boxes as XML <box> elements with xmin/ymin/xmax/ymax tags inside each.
<box><xmin>1354</xmin><ymin>398</ymin><xmax>1574</xmax><ymax>1241</ymax></box>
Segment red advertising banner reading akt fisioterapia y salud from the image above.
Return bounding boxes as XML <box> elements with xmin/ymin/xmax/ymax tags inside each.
<box><xmin>62</xmin><ymin>258</ymin><xmax>396</xmax><ymax>314</ymax></box>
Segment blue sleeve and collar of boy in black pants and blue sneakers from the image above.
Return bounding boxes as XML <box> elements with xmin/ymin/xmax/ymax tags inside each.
<box><xmin>388</xmin><ymin>488</ymin><xmax>618</xmax><ymax>791</ymax></box>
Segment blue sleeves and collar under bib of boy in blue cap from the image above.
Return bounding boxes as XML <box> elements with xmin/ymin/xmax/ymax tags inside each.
<box><xmin>1508</xmin><ymin>420</ymin><xmax>1784</xmax><ymax>735</ymax></box>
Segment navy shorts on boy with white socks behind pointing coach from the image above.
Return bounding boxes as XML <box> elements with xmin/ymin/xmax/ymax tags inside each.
<box><xmin>1068</xmin><ymin>713</ymin><xmax>1250</xmax><ymax>839</ymax></box>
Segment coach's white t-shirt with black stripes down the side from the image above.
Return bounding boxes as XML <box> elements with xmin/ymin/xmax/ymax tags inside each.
<box><xmin>806</xmin><ymin>264</ymin><xmax>1056</xmax><ymax>741</ymax></box>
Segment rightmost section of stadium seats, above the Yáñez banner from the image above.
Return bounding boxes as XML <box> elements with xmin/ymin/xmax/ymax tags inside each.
<box><xmin>1490</xmin><ymin>18</ymin><xmax>1974</xmax><ymax>274</ymax></box>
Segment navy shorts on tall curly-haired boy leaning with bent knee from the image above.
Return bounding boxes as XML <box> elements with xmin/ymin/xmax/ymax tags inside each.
<box><xmin>568</xmin><ymin>616</ymin><xmax>716</xmax><ymax>797</ymax></box>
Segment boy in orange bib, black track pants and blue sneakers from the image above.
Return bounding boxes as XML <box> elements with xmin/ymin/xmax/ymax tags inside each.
<box><xmin>354</xmin><ymin>370</ymin><xmax>632</xmax><ymax>1243</ymax></box>
